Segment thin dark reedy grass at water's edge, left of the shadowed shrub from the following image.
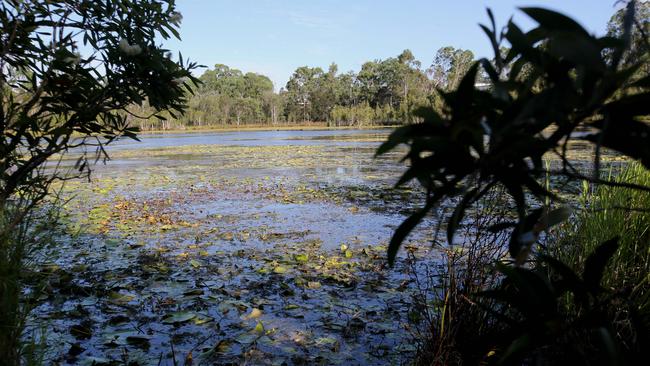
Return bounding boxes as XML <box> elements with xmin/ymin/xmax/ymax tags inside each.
<box><xmin>412</xmin><ymin>193</ymin><xmax>507</xmax><ymax>365</ymax></box>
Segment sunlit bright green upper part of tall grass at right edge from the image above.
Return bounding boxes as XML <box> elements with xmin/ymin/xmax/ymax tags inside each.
<box><xmin>555</xmin><ymin>163</ymin><xmax>650</xmax><ymax>296</ymax></box>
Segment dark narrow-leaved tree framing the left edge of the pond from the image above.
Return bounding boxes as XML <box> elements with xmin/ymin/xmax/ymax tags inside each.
<box><xmin>0</xmin><ymin>0</ymin><xmax>198</xmax><ymax>364</ymax></box>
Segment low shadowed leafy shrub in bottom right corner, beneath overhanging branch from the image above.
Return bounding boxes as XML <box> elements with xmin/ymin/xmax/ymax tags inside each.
<box><xmin>480</xmin><ymin>238</ymin><xmax>624</xmax><ymax>365</ymax></box>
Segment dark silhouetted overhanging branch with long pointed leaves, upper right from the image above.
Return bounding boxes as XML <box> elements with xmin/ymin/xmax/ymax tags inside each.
<box><xmin>377</xmin><ymin>2</ymin><xmax>650</xmax><ymax>263</ymax></box>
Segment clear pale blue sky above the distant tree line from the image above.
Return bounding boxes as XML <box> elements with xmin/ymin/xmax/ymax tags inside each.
<box><xmin>164</xmin><ymin>0</ymin><xmax>615</xmax><ymax>90</ymax></box>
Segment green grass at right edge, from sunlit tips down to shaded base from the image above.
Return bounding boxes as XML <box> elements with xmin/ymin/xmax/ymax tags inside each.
<box><xmin>548</xmin><ymin>163</ymin><xmax>650</xmax><ymax>355</ymax></box>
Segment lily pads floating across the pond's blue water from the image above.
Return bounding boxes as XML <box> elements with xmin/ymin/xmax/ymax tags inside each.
<box><xmin>30</xmin><ymin>133</ymin><xmax>430</xmax><ymax>365</ymax></box>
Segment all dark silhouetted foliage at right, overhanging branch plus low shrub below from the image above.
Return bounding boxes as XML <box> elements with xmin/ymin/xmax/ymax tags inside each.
<box><xmin>377</xmin><ymin>2</ymin><xmax>650</xmax><ymax>364</ymax></box>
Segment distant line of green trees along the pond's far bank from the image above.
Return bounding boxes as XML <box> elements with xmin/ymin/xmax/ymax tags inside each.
<box><xmin>129</xmin><ymin>47</ymin><xmax>475</xmax><ymax>130</ymax></box>
